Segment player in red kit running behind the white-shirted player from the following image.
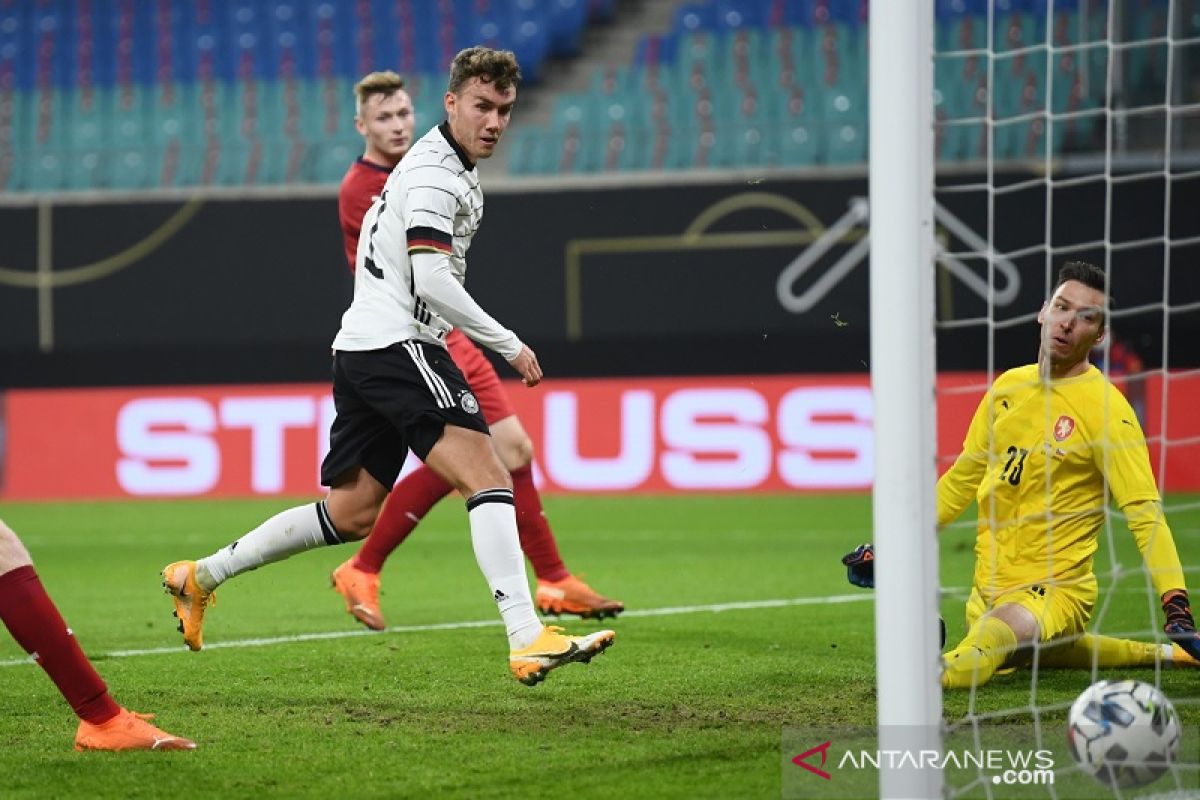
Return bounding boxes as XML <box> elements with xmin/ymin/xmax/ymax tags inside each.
<box><xmin>332</xmin><ymin>71</ymin><xmax>625</xmax><ymax>631</ymax></box>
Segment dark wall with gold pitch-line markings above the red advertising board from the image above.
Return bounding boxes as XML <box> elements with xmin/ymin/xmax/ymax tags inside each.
<box><xmin>0</xmin><ymin>174</ymin><xmax>1200</xmax><ymax>386</ymax></box>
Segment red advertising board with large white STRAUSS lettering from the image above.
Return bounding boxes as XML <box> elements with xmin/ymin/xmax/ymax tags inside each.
<box><xmin>0</xmin><ymin>374</ymin><xmax>1200</xmax><ymax>500</ymax></box>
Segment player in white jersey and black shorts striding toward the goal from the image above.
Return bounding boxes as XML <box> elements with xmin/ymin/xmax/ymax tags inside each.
<box><xmin>163</xmin><ymin>47</ymin><xmax>616</xmax><ymax>686</ymax></box>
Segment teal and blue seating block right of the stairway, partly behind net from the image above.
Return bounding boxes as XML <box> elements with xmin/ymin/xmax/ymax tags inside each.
<box><xmin>510</xmin><ymin>0</ymin><xmax>1166</xmax><ymax>174</ymax></box>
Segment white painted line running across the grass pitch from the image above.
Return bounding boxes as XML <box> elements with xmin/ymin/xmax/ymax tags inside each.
<box><xmin>0</xmin><ymin>591</ymin><xmax>875</xmax><ymax>667</ymax></box>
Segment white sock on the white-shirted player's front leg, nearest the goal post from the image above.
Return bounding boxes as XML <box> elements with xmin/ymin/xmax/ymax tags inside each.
<box><xmin>467</xmin><ymin>489</ymin><xmax>541</xmax><ymax>650</ymax></box>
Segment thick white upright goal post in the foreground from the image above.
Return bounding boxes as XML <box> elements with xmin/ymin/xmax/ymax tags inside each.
<box><xmin>869</xmin><ymin>0</ymin><xmax>942</xmax><ymax>798</ymax></box>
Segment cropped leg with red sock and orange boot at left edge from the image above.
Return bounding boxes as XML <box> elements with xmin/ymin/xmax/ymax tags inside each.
<box><xmin>0</xmin><ymin>519</ymin><xmax>196</xmax><ymax>750</ymax></box>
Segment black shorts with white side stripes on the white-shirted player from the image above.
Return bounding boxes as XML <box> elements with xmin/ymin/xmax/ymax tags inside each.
<box><xmin>320</xmin><ymin>339</ymin><xmax>487</xmax><ymax>489</ymax></box>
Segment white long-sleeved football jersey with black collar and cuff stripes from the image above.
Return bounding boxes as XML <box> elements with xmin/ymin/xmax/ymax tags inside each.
<box><xmin>334</xmin><ymin>122</ymin><xmax>522</xmax><ymax>360</ymax></box>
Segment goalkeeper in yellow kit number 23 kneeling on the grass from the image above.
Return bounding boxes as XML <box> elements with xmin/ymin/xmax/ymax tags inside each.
<box><xmin>842</xmin><ymin>261</ymin><xmax>1200</xmax><ymax>688</ymax></box>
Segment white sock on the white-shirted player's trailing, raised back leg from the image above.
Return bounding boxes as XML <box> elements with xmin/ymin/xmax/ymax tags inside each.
<box><xmin>196</xmin><ymin>500</ymin><xmax>342</xmax><ymax>591</ymax></box>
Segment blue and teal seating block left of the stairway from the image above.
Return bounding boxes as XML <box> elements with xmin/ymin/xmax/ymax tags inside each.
<box><xmin>0</xmin><ymin>0</ymin><xmax>600</xmax><ymax>192</ymax></box>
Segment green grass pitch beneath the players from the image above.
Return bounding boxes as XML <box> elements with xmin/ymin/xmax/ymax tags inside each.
<box><xmin>0</xmin><ymin>494</ymin><xmax>1200</xmax><ymax>798</ymax></box>
